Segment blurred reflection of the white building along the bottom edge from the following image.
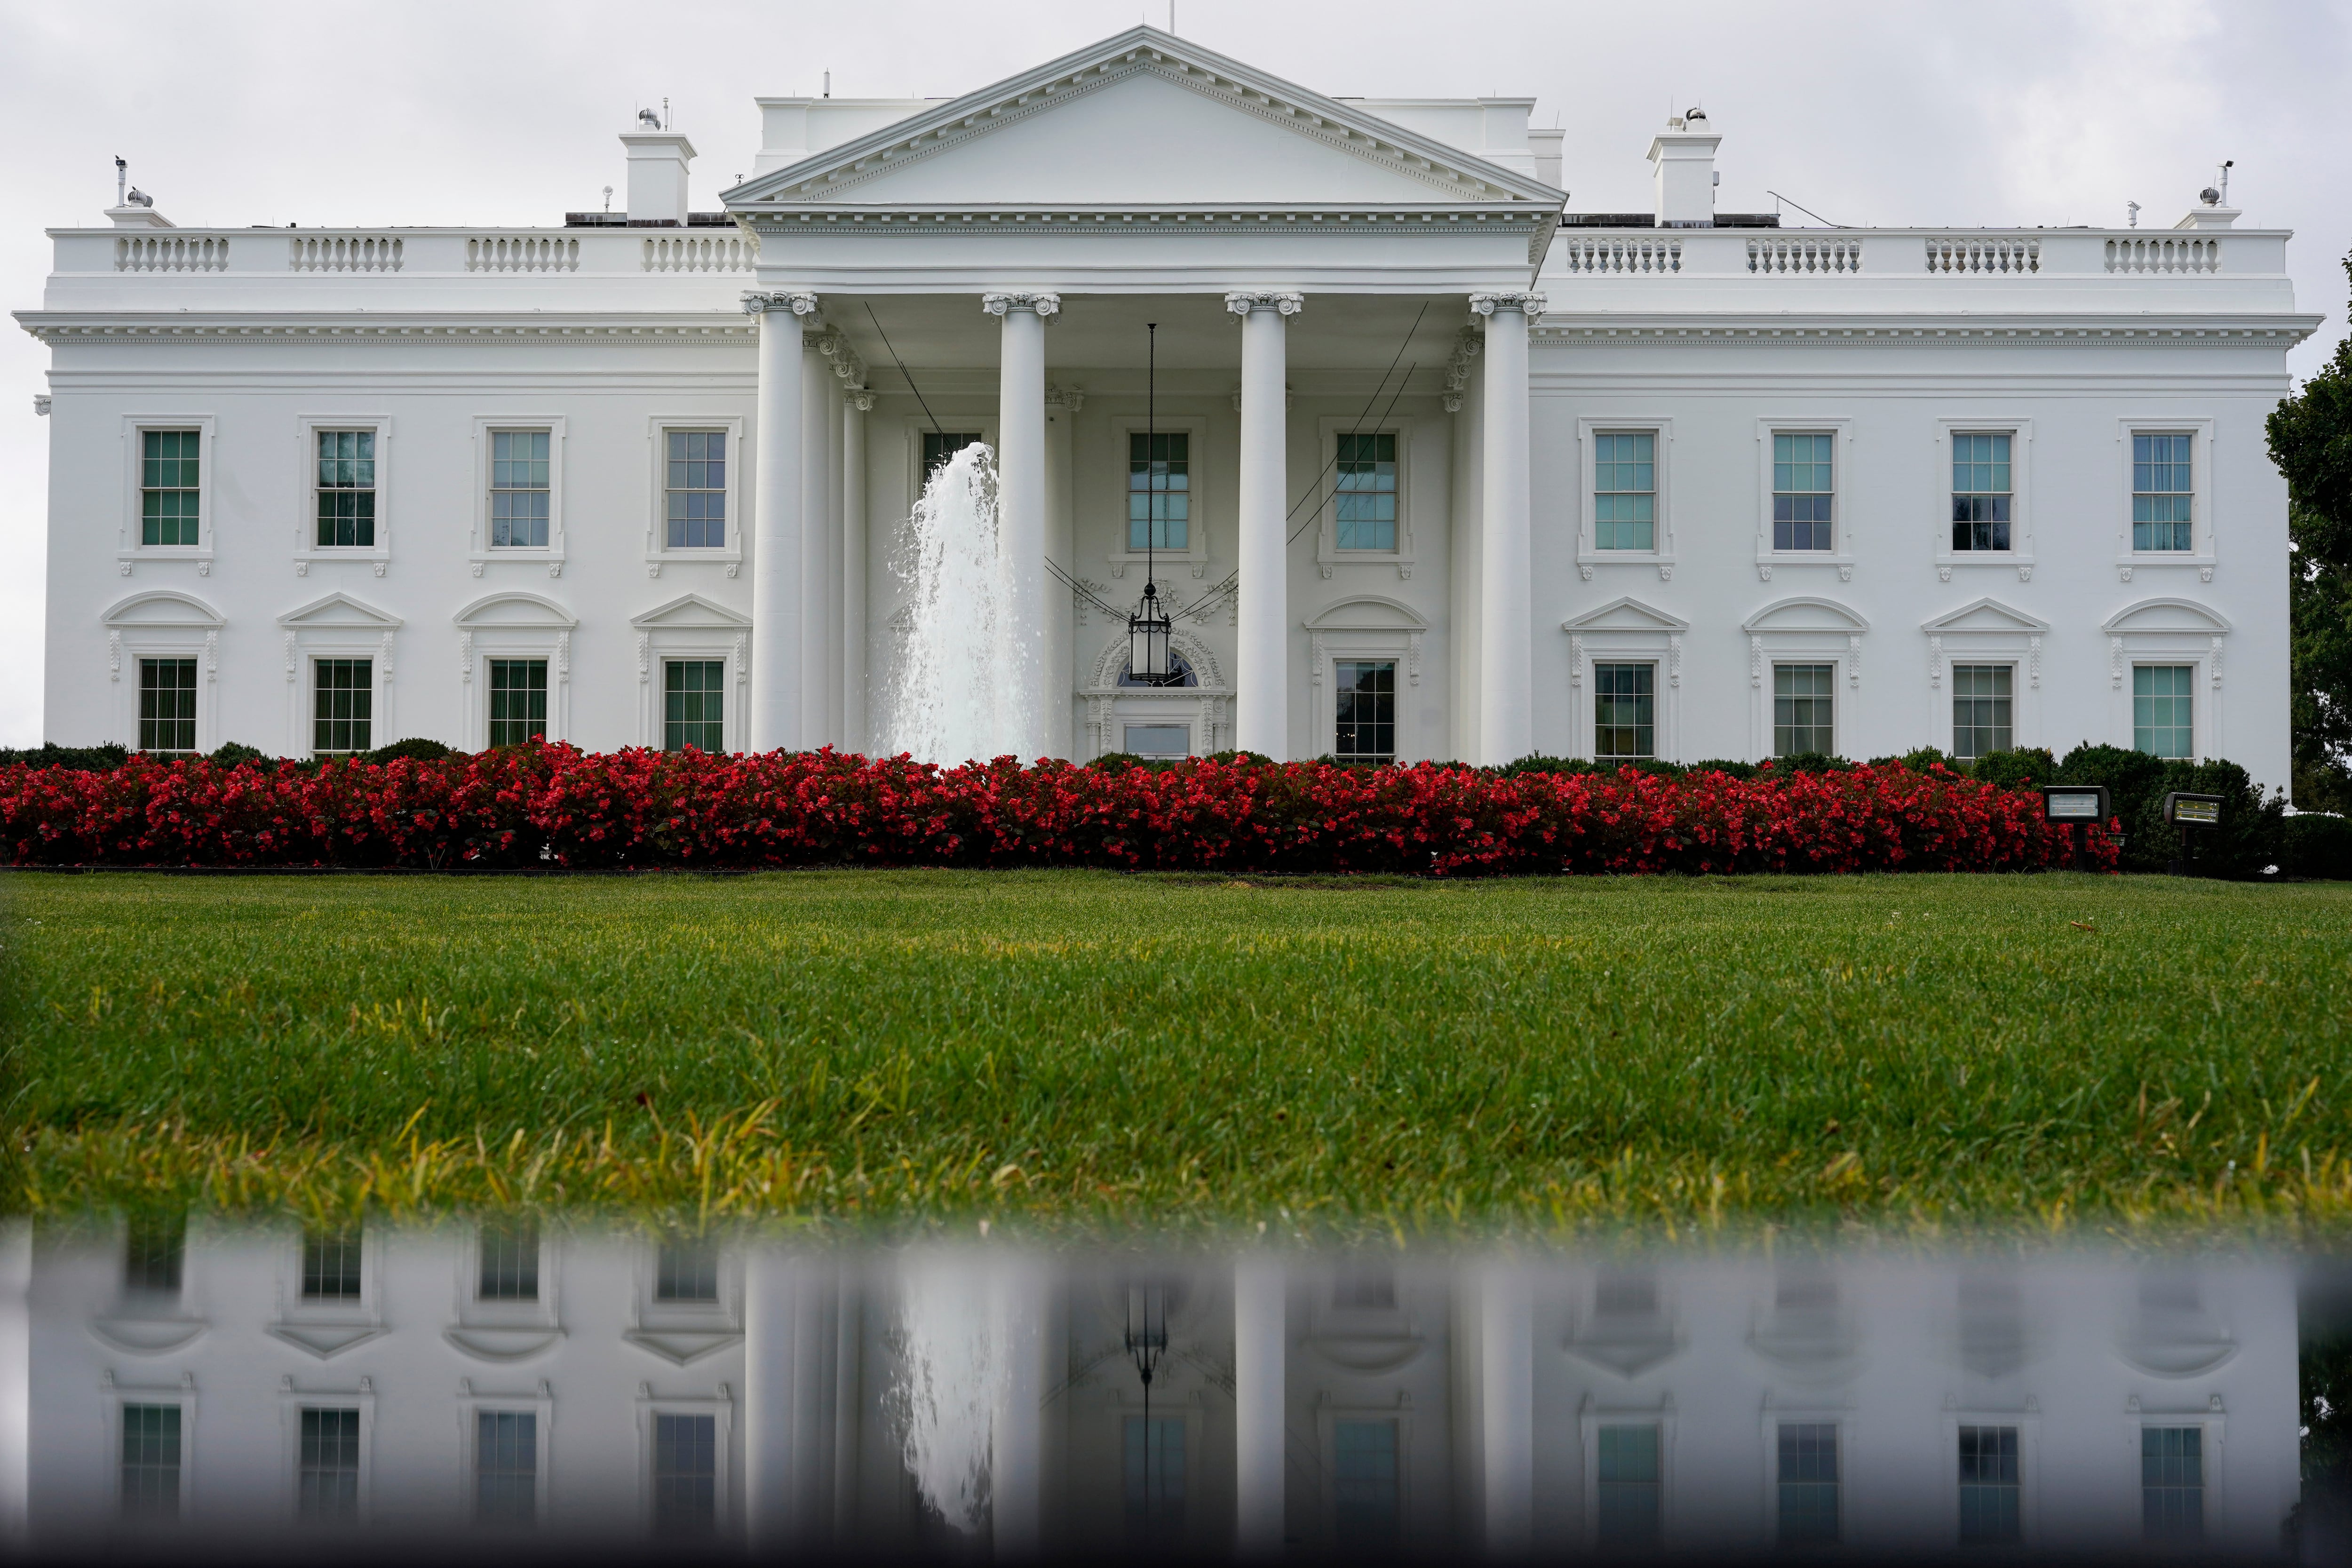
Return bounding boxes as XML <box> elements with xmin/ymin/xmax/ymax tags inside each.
<box><xmin>0</xmin><ymin>1220</ymin><xmax>2340</xmax><ymax>1561</ymax></box>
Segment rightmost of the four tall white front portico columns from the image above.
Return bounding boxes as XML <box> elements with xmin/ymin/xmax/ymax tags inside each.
<box><xmin>1470</xmin><ymin>294</ymin><xmax>1543</xmax><ymax>766</ymax></box>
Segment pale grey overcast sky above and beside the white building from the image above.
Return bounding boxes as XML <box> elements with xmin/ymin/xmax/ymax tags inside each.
<box><xmin>0</xmin><ymin>0</ymin><xmax>2352</xmax><ymax>745</ymax></box>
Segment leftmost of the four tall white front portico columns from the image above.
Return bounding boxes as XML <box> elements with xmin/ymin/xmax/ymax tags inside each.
<box><xmin>753</xmin><ymin>294</ymin><xmax>816</xmax><ymax>752</ymax></box>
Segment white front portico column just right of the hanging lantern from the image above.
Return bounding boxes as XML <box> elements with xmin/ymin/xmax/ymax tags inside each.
<box><xmin>1225</xmin><ymin>294</ymin><xmax>1305</xmax><ymax>762</ymax></box>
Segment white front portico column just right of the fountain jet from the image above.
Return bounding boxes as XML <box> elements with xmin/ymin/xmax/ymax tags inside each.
<box><xmin>981</xmin><ymin>294</ymin><xmax>1061</xmax><ymax>762</ymax></box>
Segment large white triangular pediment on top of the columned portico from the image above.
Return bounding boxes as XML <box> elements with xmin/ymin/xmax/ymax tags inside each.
<box><xmin>722</xmin><ymin>26</ymin><xmax>1562</xmax><ymax>212</ymax></box>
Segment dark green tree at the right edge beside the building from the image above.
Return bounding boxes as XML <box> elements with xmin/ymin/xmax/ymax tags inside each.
<box><xmin>2270</xmin><ymin>256</ymin><xmax>2352</xmax><ymax>811</ymax></box>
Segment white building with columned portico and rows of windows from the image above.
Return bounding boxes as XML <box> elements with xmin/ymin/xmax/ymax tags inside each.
<box><xmin>16</xmin><ymin>28</ymin><xmax>2319</xmax><ymax>785</ymax></box>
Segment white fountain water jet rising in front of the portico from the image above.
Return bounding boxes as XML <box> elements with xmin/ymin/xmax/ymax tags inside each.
<box><xmin>882</xmin><ymin>442</ymin><xmax>1044</xmax><ymax>766</ymax></box>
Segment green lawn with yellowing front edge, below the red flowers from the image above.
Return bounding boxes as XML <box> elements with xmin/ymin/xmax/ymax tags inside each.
<box><xmin>0</xmin><ymin>872</ymin><xmax>2352</xmax><ymax>1236</ymax></box>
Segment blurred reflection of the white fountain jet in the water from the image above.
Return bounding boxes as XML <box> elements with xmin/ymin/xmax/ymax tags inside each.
<box><xmin>889</xmin><ymin>1260</ymin><xmax>1004</xmax><ymax>1535</ymax></box>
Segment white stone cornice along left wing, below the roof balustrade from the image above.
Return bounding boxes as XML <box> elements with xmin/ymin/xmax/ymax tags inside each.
<box><xmin>16</xmin><ymin>310</ymin><xmax>760</xmax><ymax>346</ymax></box>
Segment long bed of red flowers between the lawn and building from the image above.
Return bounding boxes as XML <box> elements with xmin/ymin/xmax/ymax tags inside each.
<box><xmin>0</xmin><ymin>745</ymin><xmax>2117</xmax><ymax>877</ymax></box>
